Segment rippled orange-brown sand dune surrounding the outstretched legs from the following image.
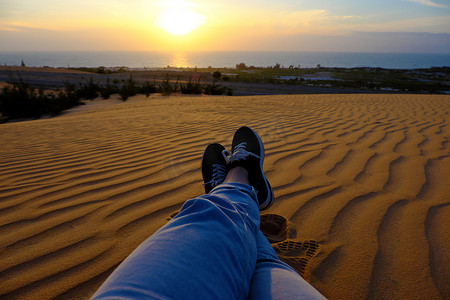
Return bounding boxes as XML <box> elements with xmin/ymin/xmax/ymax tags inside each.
<box><xmin>0</xmin><ymin>95</ymin><xmax>450</xmax><ymax>299</ymax></box>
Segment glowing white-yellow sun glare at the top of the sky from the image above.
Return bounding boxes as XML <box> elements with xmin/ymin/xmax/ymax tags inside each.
<box><xmin>156</xmin><ymin>0</ymin><xmax>205</xmax><ymax>36</ymax></box>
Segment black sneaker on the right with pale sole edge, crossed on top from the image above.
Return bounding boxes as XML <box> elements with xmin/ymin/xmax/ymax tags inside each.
<box><xmin>227</xmin><ymin>126</ymin><xmax>274</xmax><ymax>210</ymax></box>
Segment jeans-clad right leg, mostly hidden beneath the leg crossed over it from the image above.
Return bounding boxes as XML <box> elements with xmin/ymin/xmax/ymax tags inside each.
<box><xmin>248</xmin><ymin>231</ymin><xmax>325</xmax><ymax>300</ymax></box>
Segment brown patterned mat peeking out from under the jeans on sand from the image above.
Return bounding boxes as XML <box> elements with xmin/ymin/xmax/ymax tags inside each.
<box><xmin>167</xmin><ymin>211</ymin><xmax>319</xmax><ymax>281</ymax></box>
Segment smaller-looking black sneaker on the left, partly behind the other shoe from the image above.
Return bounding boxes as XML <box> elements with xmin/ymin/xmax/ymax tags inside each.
<box><xmin>202</xmin><ymin>143</ymin><xmax>227</xmax><ymax>194</ymax></box>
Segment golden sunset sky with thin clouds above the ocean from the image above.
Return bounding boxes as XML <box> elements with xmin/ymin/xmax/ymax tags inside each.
<box><xmin>0</xmin><ymin>0</ymin><xmax>450</xmax><ymax>53</ymax></box>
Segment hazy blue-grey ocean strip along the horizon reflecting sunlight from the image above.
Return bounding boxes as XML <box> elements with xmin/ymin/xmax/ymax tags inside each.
<box><xmin>0</xmin><ymin>51</ymin><xmax>450</xmax><ymax>69</ymax></box>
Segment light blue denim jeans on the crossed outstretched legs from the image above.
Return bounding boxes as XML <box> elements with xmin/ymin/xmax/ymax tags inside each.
<box><xmin>93</xmin><ymin>183</ymin><xmax>325</xmax><ymax>299</ymax></box>
